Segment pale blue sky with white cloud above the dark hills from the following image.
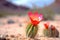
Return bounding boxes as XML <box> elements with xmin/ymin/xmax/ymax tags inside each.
<box><xmin>7</xmin><ymin>0</ymin><xmax>55</xmax><ymax>8</ymax></box>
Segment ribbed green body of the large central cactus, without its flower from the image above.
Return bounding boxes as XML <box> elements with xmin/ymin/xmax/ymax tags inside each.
<box><xmin>26</xmin><ymin>24</ymin><xmax>38</xmax><ymax>38</ymax></box>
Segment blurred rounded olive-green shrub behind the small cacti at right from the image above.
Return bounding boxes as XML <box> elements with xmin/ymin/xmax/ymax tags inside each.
<box><xmin>42</xmin><ymin>8</ymin><xmax>55</xmax><ymax>20</ymax></box>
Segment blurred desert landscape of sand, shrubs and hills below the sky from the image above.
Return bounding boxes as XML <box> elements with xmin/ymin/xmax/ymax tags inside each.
<box><xmin>0</xmin><ymin>0</ymin><xmax>60</xmax><ymax>40</ymax></box>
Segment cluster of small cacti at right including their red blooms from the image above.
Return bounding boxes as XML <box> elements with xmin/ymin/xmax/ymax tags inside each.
<box><xmin>43</xmin><ymin>23</ymin><xmax>59</xmax><ymax>37</ymax></box>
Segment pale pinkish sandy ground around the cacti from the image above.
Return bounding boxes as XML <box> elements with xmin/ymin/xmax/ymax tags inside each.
<box><xmin>0</xmin><ymin>17</ymin><xmax>60</xmax><ymax>40</ymax></box>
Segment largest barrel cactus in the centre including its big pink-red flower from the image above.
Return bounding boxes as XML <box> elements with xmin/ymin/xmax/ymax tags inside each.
<box><xmin>26</xmin><ymin>12</ymin><xmax>43</xmax><ymax>38</ymax></box>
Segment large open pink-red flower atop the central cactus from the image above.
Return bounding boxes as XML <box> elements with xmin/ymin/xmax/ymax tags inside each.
<box><xmin>28</xmin><ymin>12</ymin><xmax>43</xmax><ymax>25</ymax></box>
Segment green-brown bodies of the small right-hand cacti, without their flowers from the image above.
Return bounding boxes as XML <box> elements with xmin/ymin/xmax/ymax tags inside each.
<box><xmin>43</xmin><ymin>29</ymin><xmax>59</xmax><ymax>37</ymax></box>
